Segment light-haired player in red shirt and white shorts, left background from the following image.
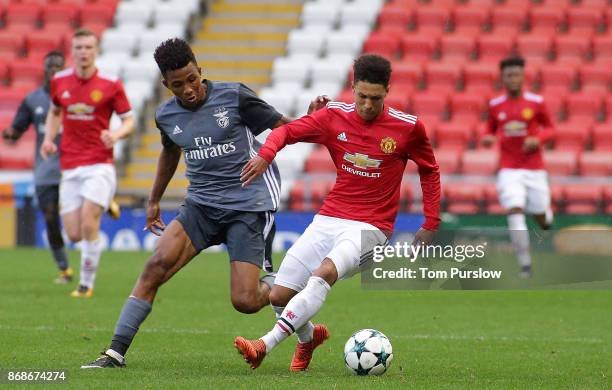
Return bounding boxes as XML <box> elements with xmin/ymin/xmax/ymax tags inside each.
<box><xmin>40</xmin><ymin>30</ymin><xmax>134</xmax><ymax>297</ymax></box>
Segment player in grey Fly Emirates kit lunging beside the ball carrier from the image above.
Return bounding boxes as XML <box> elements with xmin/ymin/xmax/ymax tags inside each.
<box><xmin>81</xmin><ymin>38</ymin><xmax>328</xmax><ymax>368</ymax></box>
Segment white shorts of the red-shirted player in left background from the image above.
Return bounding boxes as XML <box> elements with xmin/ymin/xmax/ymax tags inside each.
<box><xmin>60</xmin><ymin>164</ymin><xmax>117</xmax><ymax>214</ymax></box>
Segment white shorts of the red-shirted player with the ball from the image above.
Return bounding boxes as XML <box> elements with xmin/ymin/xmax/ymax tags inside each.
<box><xmin>274</xmin><ymin>214</ymin><xmax>387</xmax><ymax>291</ymax></box>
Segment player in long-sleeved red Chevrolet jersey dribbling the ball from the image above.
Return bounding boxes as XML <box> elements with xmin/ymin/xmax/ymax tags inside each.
<box><xmin>234</xmin><ymin>54</ymin><xmax>440</xmax><ymax>371</ymax></box>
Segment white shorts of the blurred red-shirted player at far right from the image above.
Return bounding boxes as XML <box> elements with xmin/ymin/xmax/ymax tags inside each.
<box><xmin>497</xmin><ymin>168</ymin><xmax>550</xmax><ymax>214</ymax></box>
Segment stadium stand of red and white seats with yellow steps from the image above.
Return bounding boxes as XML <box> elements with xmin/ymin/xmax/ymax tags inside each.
<box><xmin>0</xmin><ymin>0</ymin><xmax>612</xmax><ymax>214</ymax></box>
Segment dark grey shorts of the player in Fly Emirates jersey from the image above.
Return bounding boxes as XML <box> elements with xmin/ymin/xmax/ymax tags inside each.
<box><xmin>176</xmin><ymin>199</ymin><xmax>275</xmax><ymax>268</ymax></box>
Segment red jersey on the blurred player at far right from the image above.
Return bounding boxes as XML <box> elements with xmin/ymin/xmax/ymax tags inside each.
<box><xmin>487</xmin><ymin>92</ymin><xmax>554</xmax><ymax>169</ymax></box>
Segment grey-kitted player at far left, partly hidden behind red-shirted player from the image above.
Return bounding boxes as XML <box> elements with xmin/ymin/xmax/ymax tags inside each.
<box><xmin>2</xmin><ymin>51</ymin><xmax>73</xmax><ymax>284</ymax></box>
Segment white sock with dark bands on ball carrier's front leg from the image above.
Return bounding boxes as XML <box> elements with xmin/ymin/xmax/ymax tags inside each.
<box><xmin>261</xmin><ymin>276</ymin><xmax>331</xmax><ymax>352</ymax></box>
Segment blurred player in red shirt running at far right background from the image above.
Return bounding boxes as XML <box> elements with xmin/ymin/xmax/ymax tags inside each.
<box><xmin>481</xmin><ymin>57</ymin><xmax>554</xmax><ymax>278</ymax></box>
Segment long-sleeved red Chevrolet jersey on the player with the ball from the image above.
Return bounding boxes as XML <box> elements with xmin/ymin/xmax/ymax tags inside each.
<box><xmin>259</xmin><ymin>102</ymin><xmax>440</xmax><ymax>232</ymax></box>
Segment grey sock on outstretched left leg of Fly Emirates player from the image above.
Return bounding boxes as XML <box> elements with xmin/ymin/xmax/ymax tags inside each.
<box><xmin>111</xmin><ymin>297</ymin><xmax>151</xmax><ymax>356</ymax></box>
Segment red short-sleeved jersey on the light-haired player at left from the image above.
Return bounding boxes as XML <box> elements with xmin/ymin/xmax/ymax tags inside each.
<box><xmin>51</xmin><ymin>68</ymin><xmax>131</xmax><ymax>169</ymax></box>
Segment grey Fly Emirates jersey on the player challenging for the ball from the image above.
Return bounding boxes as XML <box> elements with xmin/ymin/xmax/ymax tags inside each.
<box><xmin>155</xmin><ymin>80</ymin><xmax>282</xmax><ymax>211</ymax></box>
